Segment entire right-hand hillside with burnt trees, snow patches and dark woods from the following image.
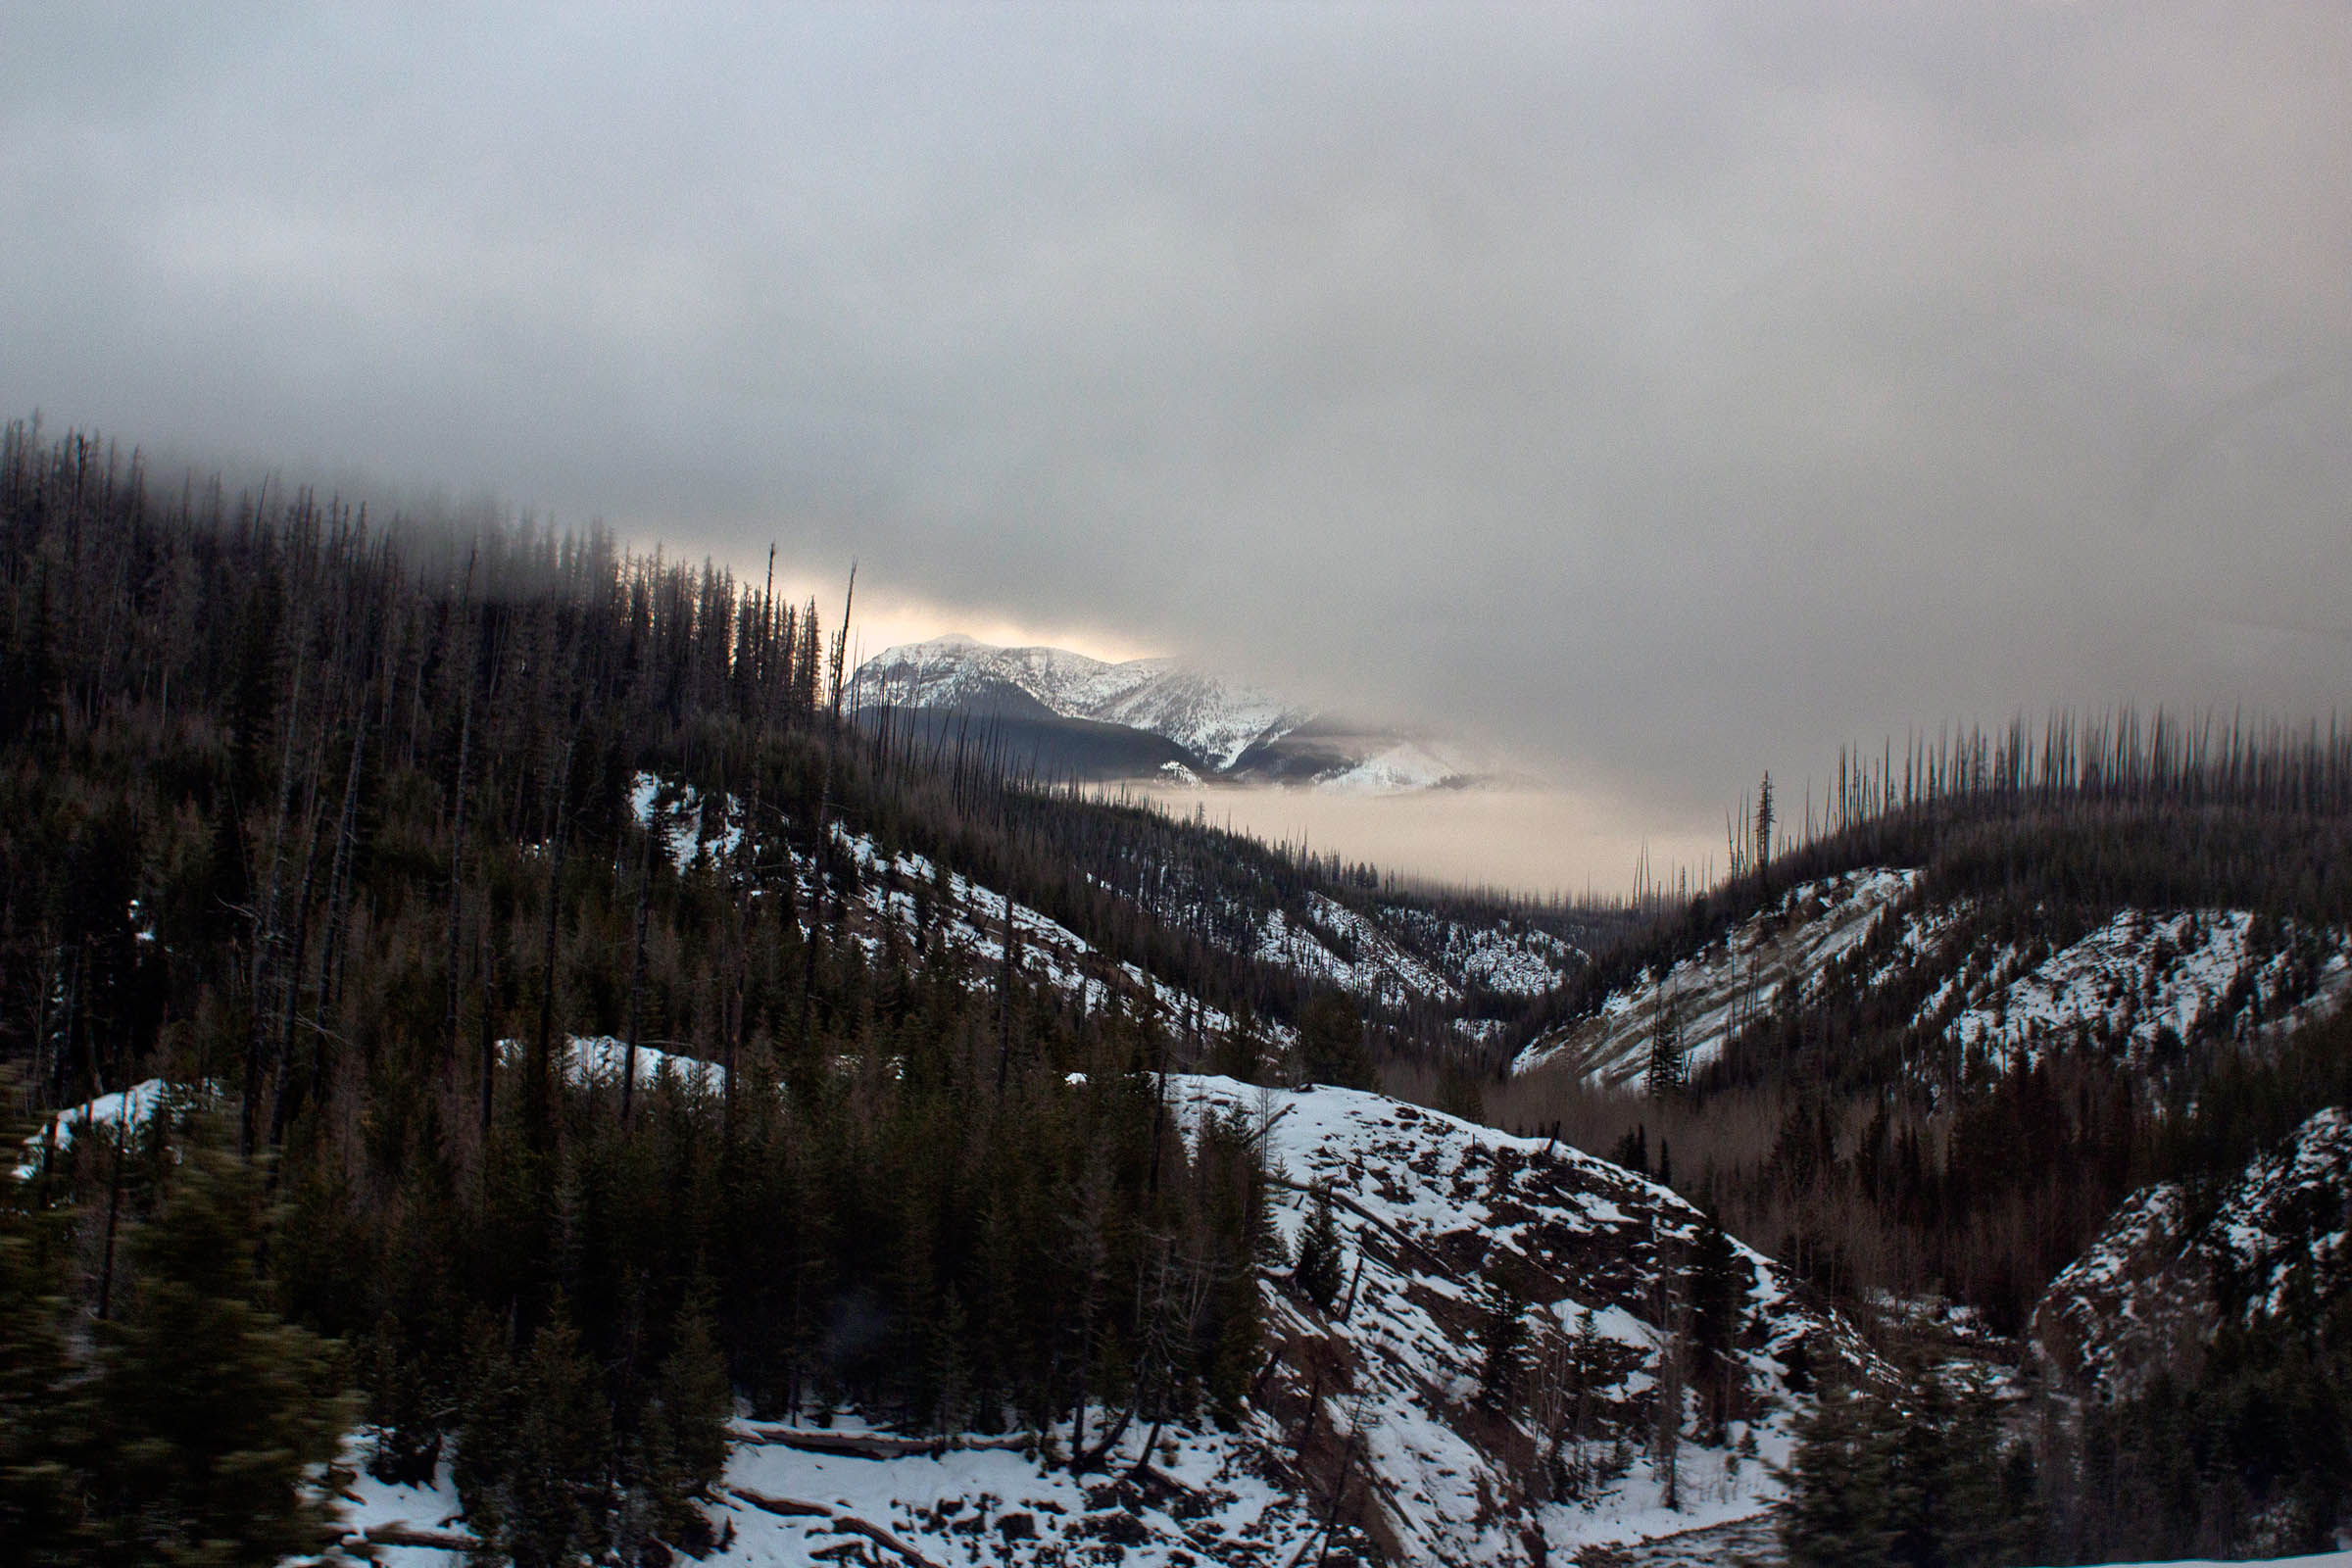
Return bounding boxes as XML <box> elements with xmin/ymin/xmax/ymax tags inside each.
<box><xmin>1487</xmin><ymin>733</ymin><xmax>2352</xmax><ymax>1561</ymax></box>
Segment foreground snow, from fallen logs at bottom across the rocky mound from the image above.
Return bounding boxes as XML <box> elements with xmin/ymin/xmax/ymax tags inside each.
<box><xmin>353</xmin><ymin>1067</ymin><xmax>1870</xmax><ymax>1568</ymax></box>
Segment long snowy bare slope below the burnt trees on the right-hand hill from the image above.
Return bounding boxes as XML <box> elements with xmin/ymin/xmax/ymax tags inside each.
<box><xmin>1515</xmin><ymin>870</ymin><xmax>2352</xmax><ymax>1086</ymax></box>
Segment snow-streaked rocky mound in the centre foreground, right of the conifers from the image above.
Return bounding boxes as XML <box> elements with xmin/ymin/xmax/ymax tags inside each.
<box><xmin>1169</xmin><ymin>1077</ymin><xmax>1870</xmax><ymax>1563</ymax></box>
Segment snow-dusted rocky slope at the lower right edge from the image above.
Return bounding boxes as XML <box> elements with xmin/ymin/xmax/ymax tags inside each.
<box><xmin>2028</xmin><ymin>1109</ymin><xmax>2352</xmax><ymax>1396</ymax></box>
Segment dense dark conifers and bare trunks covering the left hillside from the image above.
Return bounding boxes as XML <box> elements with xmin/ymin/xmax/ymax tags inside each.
<box><xmin>0</xmin><ymin>425</ymin><xmax>1298</xmax><ymax>1563</ymax></box>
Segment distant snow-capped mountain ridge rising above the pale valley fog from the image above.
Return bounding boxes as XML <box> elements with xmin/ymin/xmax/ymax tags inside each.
<box><xmin>852</xmin><ymin>632</ymin><xmax>1470</xmax><ymax>795</ymax></box>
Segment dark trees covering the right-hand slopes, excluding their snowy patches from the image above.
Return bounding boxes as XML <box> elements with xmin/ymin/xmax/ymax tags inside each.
<box><xmin>1487</xmin><ymin>728</ymin><xmax>2352</xmax><ymax>1563</ymax></box>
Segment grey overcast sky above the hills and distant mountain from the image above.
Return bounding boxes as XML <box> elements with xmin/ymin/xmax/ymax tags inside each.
<box><xmin>0</xmin><ymin>0</ymin><xmax>2352</xmax><ymax>846</ymax></box>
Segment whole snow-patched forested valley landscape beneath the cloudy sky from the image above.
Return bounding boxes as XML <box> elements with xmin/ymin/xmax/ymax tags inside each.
<box><xmin>0</xmin><ymin>425</ymin><xmax>2352</xmax><ymax>1568</ymax></box>
